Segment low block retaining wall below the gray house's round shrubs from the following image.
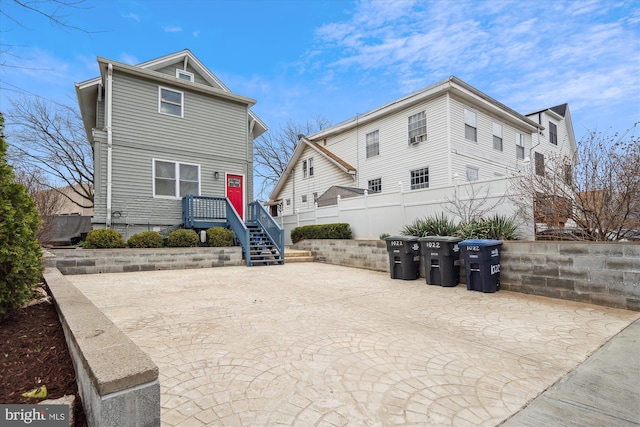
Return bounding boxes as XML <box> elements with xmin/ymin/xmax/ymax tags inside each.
<box><xmin>51</xmin><ymin>246</ymin><xmax>242</xmax><ymax>274</ymax></box>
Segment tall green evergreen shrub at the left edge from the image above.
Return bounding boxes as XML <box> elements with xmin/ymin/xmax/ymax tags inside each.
<box><xmin>0</xmin><ymin>113</ymin><xmax>42</xmax><ymax>320</ymax></box>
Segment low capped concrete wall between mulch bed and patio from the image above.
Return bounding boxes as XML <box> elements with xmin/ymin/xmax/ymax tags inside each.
<box><xmin>44</xmin><ymin>262</ymin><xmax>160</xmax><ymax>427</ymax></box>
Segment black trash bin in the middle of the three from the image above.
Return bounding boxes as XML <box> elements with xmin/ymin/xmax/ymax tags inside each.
<box><xmin>418</xmin><ymin>236</ymin><xmax>462</xmax><ymax>287</ymax></box>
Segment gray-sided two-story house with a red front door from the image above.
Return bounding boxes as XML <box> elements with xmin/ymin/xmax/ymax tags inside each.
<box><xmin>76</xmin><ymin>49</ymin><xmax>282</xmax><ymax>264</ymax></box>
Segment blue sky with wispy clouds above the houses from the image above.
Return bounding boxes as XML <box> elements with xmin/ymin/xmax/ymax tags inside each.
<box><xmin>0</xmin><ymin>0</ymin><xmax>640</xmax><ymax>144</ymax></box>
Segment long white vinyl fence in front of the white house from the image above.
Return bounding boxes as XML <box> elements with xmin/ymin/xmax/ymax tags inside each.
<box><xmin>275</xmin><ymin>177</ymin><xmax>534</xmax><ymax>245</ymax></box>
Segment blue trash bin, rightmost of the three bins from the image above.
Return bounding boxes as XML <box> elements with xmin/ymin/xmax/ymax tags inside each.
<box><xmin>458</xmin><ymin>239</ymin><xmax>502</xmax><ymax>293</ymax></box>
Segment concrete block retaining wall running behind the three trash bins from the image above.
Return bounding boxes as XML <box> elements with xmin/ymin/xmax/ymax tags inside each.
<box><xmin>293</xmin><ymin>240</ymin><xmax>640</xmax><ymax>311</ymax></box>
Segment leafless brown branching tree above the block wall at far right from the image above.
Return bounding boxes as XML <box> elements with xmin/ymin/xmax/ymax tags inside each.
<box><xmin>512</xmin><ymin>123</ymin><xmax>640</xmax><ymax>240</ymax></box>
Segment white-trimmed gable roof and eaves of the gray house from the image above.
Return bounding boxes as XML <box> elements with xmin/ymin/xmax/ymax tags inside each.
<box><xmin>75</xmin><ymin>49</ymin><xmax>268</xmax><ymax>140</ymax></box>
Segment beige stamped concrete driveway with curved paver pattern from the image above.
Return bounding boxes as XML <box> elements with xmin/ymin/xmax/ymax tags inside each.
<box><xmin>67</xmin><ymin>263</ymin><xmax>640</xmax><ymax>426</ymax></box>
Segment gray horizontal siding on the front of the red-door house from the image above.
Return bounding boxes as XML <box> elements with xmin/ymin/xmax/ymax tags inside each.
<box><xmin>96</xmin><ymin>67</ymin><xmax>253</xmax><ymax>227</ymax></box>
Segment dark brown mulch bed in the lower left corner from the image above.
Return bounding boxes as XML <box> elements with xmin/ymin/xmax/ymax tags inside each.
<box><xmin>0</xmin><ymin>286</ymin><xmax>87</xmax><ymax>427</ymax></box>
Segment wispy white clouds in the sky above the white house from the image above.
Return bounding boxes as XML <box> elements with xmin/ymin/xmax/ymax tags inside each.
<box><xmin>308</xmin><ymin>1</ymin><xmax>640</xmax><ymax>132</ymax></box>
